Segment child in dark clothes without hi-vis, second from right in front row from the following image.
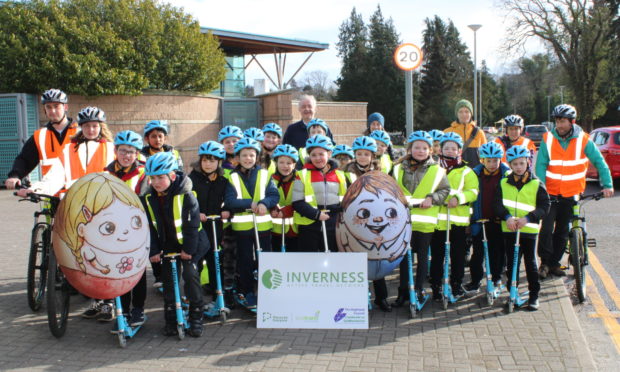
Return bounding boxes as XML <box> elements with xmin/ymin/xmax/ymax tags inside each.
<box><xmin>464</xmin><ymin>142</ymin><xmax>510</xmax><ymax>294</ymax></box>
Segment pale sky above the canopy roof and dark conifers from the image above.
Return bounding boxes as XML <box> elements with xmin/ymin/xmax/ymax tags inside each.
<box><xmin>169</xmin><ymin>0</ymin><xmax>543</xmax><ymax>88</ymax></box>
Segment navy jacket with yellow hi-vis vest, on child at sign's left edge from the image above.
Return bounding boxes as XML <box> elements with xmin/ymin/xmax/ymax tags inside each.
<box><xmin>224</xmin><ymin>166</ymin><xmax>280</xmax><ymax>232</ymax></box>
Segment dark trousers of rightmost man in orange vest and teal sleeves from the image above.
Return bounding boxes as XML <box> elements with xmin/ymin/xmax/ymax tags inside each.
<box><xmin>538</xmin><ymin>196</ymin><xmax>576</xmax><ymax>267</ymax></box>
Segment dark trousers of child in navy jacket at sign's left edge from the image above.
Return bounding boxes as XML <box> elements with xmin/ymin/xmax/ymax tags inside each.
<box><xmin>237</xmin><ymin>231</ymin><xmax>271</xmax><ymax>295</ymax></box>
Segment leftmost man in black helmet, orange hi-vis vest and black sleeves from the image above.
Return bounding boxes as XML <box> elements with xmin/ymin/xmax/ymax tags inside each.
<box><xmin>4</xmin><ymin>89</ymin><xmax>77</xmax><ymax>189</ymax></box>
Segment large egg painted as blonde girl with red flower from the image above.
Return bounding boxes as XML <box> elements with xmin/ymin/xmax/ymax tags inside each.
<box><xmin>52</xmin><ymin>173</ymin><xmax>150</xmax><ymax>299</ymax></box>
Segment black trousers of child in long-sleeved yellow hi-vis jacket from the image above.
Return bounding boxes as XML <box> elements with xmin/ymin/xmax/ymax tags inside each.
<box><xmin>430</xmin><ymin>226</ymin><xmax>467</xmax><ymax>288</ymax></box>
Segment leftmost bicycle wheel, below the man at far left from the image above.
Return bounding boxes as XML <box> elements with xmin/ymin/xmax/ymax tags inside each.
<box><xmin>27</xmin><ymin>222</ymin><xmax>50</xmax><ymax>311</ymax></box>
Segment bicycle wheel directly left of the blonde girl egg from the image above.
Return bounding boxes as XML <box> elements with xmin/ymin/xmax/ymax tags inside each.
<box><xmin>47</xmin><ymin>247</ymin><xmax>69</xmax><ymax>338</ymax></box>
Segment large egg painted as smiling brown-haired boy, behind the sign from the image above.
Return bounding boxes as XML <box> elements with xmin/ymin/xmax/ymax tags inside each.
<box><xmin>336</xmin><ymin>171</ymin><xmax>411</xmax><ymax>280</ymax></box>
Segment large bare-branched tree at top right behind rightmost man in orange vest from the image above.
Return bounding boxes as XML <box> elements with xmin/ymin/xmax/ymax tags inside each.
<box><xmin>503</xmin><ymin>0</ymin><xmax>617</xmax><ymax>130</ymax></box>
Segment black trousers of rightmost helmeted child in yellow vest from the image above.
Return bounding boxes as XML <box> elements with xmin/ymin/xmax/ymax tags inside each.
<box><xmin>504</xmin><ymin>233</ymin><xmax>540</xmax><ymax>299</ymax></box>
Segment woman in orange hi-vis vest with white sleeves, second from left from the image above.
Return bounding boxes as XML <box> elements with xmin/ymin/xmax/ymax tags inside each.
<box><xmin>18</xmin><ymin>107</ymin><xmax>114</xmax><ymax>196</ymax></box>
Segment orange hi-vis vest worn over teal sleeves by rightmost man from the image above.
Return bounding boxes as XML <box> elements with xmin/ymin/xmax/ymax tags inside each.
<box><xmin>542</xmin><ymin>132</ymin><xmax>590</xmax><ymax>197</ymax></box>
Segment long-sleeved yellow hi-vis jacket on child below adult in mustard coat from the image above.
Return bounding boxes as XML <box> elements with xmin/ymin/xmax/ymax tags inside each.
<box><xmin>437</xmin><ymin>164</ymin><xmax>478</xmax><ymax>231</ymax></box>
